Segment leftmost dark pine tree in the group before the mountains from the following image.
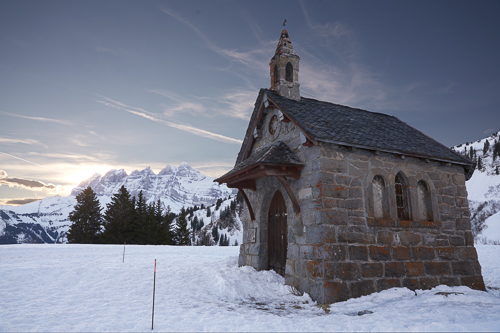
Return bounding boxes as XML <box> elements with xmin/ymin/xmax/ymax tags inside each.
<box><xmin>67</xmin><ymin>186</ymin><xmax>102</xmax><ymax>244</ymax></box>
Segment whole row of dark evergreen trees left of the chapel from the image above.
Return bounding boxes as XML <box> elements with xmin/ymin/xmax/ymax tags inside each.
<box><xmin>67</xmin><ymin>186</ymin><xmax>191</xmax><ymax>245</ymax></box>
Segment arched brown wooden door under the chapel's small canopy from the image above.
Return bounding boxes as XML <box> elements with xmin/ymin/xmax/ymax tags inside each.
<box><xmin>267</xmin><ymin>191</ymin><xmax>288</xmax><ymax>276</ymax></box>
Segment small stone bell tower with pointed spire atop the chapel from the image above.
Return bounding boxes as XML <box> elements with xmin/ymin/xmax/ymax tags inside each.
<box><xmin>269</xmin><ymin>29</ymin><xmax>300</xmax><ymax>101</ymax></box>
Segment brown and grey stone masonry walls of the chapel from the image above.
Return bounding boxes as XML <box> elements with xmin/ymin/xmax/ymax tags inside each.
<box><xmin>239</xmin><ymin>108</ymin><xmax>485</xmax><ymax>303</ymax></box>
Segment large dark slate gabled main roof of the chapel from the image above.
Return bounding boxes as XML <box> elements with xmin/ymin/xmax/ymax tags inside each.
<box><xmin>236</xmin><ymin>89</ymin><xmax>473</xmax><ymax>171</ymax></box>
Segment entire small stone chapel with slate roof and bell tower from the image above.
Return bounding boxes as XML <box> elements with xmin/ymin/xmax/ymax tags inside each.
<box><xmin>216</xmin><ymin>29</ymin><xmax>485</xmax><ymax>304</ymax></box>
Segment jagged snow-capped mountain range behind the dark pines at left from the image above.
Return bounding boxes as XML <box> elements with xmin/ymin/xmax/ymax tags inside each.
<box><xmin>0</xmin><ymin>163</ymin><xmax>236</xmax><ymax>244</ymax></box>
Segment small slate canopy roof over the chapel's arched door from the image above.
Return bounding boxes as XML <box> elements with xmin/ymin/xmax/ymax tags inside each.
<box><xmin>219</xmin><ymin>141</ymin><xmax>303</xmax><ymax>179</ymax></box>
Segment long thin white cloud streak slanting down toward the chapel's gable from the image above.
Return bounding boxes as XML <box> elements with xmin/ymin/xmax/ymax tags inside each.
<box><xmin>96</xmin><ymin>95</ymin><xmax>242</xmax><ymax>144</ymax></box>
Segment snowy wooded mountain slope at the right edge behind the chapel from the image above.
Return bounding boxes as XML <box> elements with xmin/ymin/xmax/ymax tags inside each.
<box><xmin>452</xmin><ymin>132</ymin><xmax>500</xmax><ymax>244</ymax></box>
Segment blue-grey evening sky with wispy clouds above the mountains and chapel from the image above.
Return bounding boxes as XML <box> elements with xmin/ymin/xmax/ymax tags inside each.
<box><xmin>0</xmin><ymin>0</ymin><xmax>500</xmax><ymax>204</ymax></box>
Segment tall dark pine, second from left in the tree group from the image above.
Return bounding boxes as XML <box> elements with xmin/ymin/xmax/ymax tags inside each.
<box><xmin>103</xmin><ymin>185</ymin><xmax>135</xmax><ymax>244</ymax></box>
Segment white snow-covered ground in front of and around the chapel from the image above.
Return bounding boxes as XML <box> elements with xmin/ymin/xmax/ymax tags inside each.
<box><xmin>0</xmin><ymin>244</ymin><xmax>500</xmax><ymax>332</ymax></box>
